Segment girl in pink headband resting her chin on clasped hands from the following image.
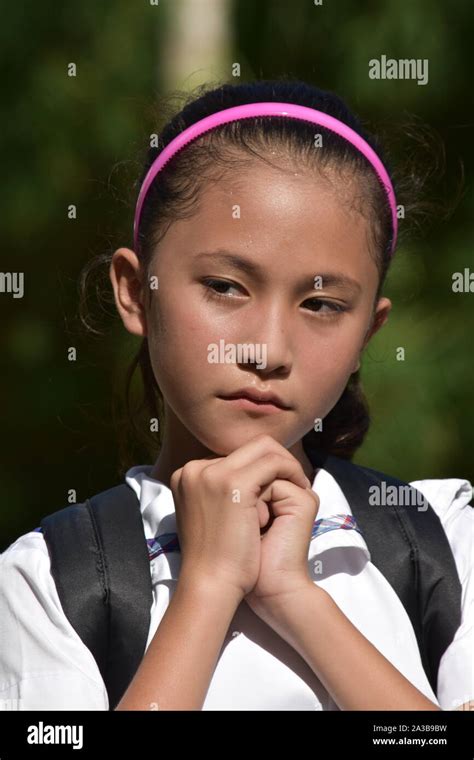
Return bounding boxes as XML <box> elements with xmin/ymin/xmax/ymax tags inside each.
<box><xmin>0</xmin><ymin>81</ymin><xmax>474</xmax><ymax>710</ymax></box>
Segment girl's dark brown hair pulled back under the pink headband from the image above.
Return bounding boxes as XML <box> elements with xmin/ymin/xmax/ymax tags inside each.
<box><xmin>80</xmin><ymin>78</ymin><xmax>456</xmax><ymax>468</ymax></box>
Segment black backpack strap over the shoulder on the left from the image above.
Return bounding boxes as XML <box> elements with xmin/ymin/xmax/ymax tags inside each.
<box><xmin>41</xmin><ymin>484</ymin><xmax>153</xmax><ymax>710</ymax></box>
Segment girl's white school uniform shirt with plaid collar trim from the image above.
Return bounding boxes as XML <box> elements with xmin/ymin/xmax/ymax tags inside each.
<box><xmin>0</xmin><ymin>465</ymin><xmax>474</xmax><ymax>710</ymax></box>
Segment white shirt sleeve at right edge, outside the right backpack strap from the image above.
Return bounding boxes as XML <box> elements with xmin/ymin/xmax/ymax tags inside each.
<box><xmin>412</xmin><ymin>478</ymin><xmax>474</xmax><ymax>710</ymax></box>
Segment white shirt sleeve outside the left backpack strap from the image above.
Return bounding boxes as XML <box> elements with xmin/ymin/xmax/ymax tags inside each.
<box><xmin>0</xmin><ymin>531</ymin><xmax>109</xmax><ymax>710</ymax></box>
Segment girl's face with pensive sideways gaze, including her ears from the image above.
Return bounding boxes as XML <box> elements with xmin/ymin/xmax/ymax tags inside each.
<box><xmin>111</xmin><ymin>162</ymin><xmax>391</xmax><ymax>466</ymax></box>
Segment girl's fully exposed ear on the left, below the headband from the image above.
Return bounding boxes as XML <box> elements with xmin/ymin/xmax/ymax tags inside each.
<box><xmin>109</xmin><ymin>248</ymin><xmax>147</xmax><ymax>337</ymax></box>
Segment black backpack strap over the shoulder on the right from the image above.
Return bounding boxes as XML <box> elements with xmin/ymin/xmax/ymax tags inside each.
<box><xmin>303</xmin><ymin>439</ymin><xmax>462</xmax><ymax>694</ymax></box>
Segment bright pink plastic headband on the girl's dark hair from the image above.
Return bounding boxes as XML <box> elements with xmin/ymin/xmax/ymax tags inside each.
<box><xmin>133</xmin><ymin>101</ymin><xmax>398</xmax><ymax>255</ymax></box>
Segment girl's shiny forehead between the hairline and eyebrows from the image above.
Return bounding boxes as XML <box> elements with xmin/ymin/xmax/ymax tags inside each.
<box><xmin>154</xmin><ymin>162</ymin><xmax>374</xmax><ymax>279</ymax></box>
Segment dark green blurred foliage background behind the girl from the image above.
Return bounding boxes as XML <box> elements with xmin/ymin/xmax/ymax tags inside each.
<box><xmin>0</xmin><ymin>0</ymin><xmax>474</xmax><ymax>550</ymax></box>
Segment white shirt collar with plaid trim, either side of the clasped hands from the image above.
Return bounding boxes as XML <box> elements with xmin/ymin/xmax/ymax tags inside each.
<box><xmin>125</xmin><ymin>465</ymin><xmax>370</xmax><ymax>580</ymax></box>
